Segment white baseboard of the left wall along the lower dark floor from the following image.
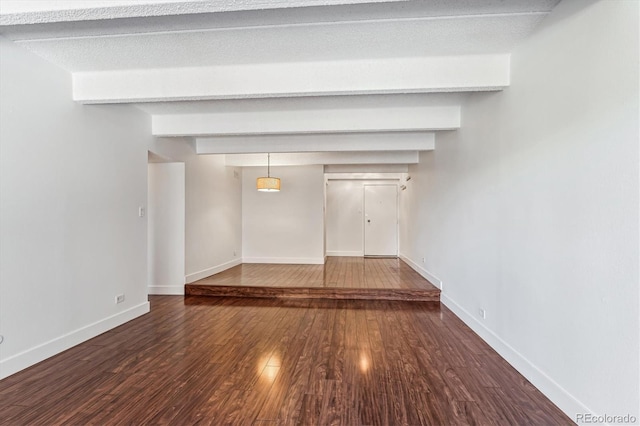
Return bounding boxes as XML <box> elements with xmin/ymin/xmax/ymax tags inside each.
<box><xmin>0</xmin><ymin>302</ymin><xmax>150</xmax><ymax>379</ymax></box>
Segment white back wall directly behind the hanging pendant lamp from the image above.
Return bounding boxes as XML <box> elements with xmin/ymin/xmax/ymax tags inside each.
<box><xmin>242</xmin><ymin>166</ymin><xmax>324</xmax><ymax>263</ymax></box>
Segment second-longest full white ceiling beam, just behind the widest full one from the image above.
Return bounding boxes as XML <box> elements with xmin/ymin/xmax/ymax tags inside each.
<box><xmin>151</xmin><ymin>106</ymin><xmax>460</xmax><ymax>136</ymax></box>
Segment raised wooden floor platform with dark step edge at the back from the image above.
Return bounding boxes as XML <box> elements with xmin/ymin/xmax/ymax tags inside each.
<box><xmin>185</xmin><ymin>257</ymin><xmax>440</xmax><ymax>302</ymax></box>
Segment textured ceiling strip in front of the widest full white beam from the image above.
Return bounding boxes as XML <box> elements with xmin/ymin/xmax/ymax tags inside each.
<box><xmin>11</xmin><ymin>13</ymin><xmax>545</xmax><ymax>72</ymax></box>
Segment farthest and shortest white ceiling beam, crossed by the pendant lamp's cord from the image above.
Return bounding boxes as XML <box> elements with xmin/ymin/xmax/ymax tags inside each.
<box><xmin>225</xmin><ymin>151</ymin><xmax>419</xmax><ymax>168</ymax></box>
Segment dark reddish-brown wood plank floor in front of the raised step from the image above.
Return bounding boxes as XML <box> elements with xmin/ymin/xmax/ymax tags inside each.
<box><xmin>0</xmin><ymin>296</ymin><xmax>572</xmax><ymax>426</ymax></box>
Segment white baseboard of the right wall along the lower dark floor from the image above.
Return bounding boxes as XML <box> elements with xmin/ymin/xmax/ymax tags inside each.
<box><xmin>440</xmin><ymin>294</ymin><xmax>594</xmax><ymax>422</ymax></box>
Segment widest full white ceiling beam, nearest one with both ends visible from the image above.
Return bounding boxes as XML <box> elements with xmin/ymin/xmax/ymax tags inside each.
<box><xmin>73</xmin><ymin>54</ymin><xmax>510</xmax><ymax>104</ymax></box>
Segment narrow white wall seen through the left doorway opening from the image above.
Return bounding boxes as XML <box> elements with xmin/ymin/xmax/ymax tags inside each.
<box><xmin>147</xmin><ymin>163</ymin><xmax>185</xmax><ymax>294</ymax></box>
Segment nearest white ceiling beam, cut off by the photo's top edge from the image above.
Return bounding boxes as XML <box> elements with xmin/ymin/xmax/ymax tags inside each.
<box><xmin>0</xmin><ymin>0</ymin><xmax>559</xmax><ymax>26</ymax></box>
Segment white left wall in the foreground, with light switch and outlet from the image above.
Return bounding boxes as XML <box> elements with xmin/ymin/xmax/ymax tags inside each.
<box><xmin>0</xmin><ymin>38</ymin><xmax>151</xmax><ymax>378</ymax></box>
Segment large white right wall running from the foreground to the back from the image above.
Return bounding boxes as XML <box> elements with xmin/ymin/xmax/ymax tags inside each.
<box><xmin>401</xmin><ymin>0</ymin><xmax>640</xmax><ymax>420</ymax></box>
